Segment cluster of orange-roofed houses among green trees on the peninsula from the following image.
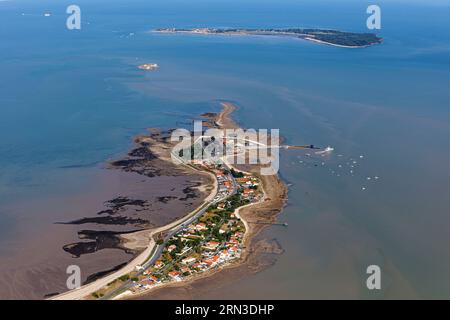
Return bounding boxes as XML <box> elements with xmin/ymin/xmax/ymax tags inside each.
<box><xmin>127</xmin><ymin>163</ymin><xmax>262</xmax><ymax>291</ymax></box>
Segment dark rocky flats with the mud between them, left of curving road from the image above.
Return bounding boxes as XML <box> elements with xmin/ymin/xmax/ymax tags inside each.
<box><xmin>56</xmin><ymin>129</ymin><xmax>212</xmax><ymax>288</ymax></box>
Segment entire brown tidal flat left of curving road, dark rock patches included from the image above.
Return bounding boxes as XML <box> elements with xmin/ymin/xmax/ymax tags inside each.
<box><xmin>0</xmin><ymin>130</ymin><xmax>212</xmax><ymax>299</ymax></box>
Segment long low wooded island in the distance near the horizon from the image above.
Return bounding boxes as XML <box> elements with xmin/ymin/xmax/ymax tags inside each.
<box><xmin>153</xmin><ymin>28</ymin><xmax>383</xmax><ymax>48</ymax></box>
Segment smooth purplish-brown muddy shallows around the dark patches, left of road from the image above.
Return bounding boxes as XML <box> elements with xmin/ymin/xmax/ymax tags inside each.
<box><xmin>0</xmin><ymin>165</ymin><xmax>210</xmax><ymax>299</ymax></box>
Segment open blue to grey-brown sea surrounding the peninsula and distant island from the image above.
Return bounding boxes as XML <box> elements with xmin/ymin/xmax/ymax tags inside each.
<box><xmin>0</xmin><ymin>0</ymin><xmax>450</xmax><ymax>298</ymax></box>
